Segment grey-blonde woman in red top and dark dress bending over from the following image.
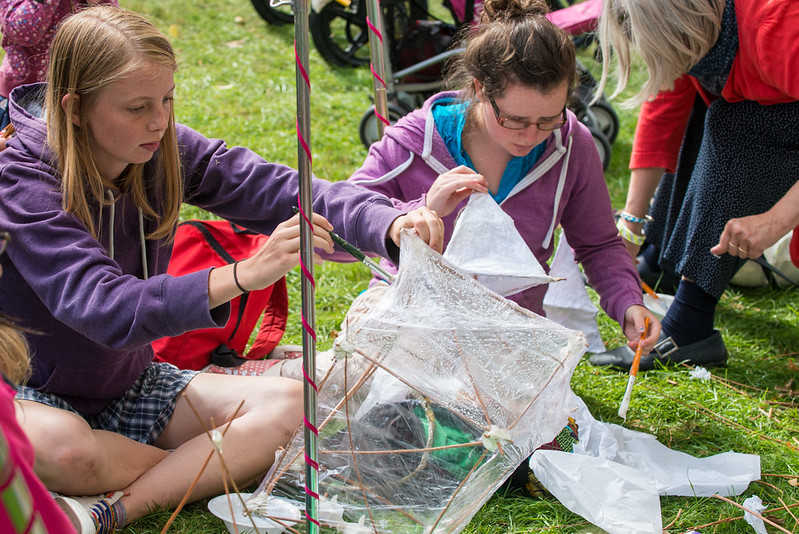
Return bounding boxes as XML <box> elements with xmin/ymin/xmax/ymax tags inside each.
<box><xmin>591</xmin><ymin>0</ymin><xmax>799</xmax><ymax>369</ymax></box>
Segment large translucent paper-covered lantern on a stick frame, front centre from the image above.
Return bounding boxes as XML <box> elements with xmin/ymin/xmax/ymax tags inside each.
<box><xmin>250</xmin><ymin>232</ymin><xmax>586</xmax><ymax>534</ymax></box>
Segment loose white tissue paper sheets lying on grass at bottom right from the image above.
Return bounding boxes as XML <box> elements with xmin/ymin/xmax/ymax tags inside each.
<box><xmin>530</xmin><ymin>395</ymin><xmax>760</xmax><ymax>534</ymax></box>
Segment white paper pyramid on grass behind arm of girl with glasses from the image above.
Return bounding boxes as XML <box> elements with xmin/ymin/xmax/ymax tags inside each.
<box><xmin>544</xmin><ymin>232</ymin><xmax>606</xmax><ymax>353</ymax></box>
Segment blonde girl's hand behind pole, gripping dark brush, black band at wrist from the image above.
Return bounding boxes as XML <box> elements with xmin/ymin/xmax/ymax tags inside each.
<box><xmin>237</xmin><ymin>214</ymin><xmax>333</xmax><ymax>291</ymax></box>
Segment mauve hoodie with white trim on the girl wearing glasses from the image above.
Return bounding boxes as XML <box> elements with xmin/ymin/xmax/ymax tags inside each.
<box><xmin>349</xmin><ymin>92</ymin><xmax>643</xmax><ymax>324</ymax></box>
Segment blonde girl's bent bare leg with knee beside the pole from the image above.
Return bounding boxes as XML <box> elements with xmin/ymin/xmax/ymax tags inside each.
<box><xmin>114</xmin><ymin>373</ymin><xmax>302</xmax><ymax>521</ymax></box>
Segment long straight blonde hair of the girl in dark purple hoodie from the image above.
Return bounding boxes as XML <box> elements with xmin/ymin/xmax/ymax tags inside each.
<box><xmin>45</xmin><ymin>6</ymin><xmax>183</xmax><ymax>238</ymax></box>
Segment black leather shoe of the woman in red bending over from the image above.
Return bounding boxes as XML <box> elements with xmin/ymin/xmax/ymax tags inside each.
<box><xmin>588</xmin><ymin>330</ymin><xmax>727</xmax><ymax>371</ymax></box>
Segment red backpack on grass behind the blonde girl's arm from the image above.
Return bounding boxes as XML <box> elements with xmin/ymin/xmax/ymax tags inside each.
<box><xmin>153</xmin><ymin>221</ymin><xmax>289</xmax><ymax>369</ymax></box>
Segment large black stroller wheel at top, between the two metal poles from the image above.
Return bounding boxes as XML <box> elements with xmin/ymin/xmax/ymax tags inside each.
<box><xmin>308</xmin><ymin>0</ymin><xmax>370</xmax><ymax>67</ymax></box>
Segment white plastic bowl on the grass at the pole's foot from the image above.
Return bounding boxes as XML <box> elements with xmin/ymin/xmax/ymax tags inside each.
<box><xmin>208</xmin><ymin>493</ymin><xmax>301</xmax><ymax>534</ymax></box>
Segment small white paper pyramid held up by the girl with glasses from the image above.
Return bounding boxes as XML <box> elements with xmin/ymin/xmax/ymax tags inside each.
<box><xmin>444</xmin><ymin>193</ymin><xmax>553</xmax><ymax>297</ymax></box>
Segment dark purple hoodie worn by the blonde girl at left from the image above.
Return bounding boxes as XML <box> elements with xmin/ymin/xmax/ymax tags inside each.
<box><xmin>0</xmin><ymin>84</ymin><xmax>401</xmax><ymax>414</ymax></box>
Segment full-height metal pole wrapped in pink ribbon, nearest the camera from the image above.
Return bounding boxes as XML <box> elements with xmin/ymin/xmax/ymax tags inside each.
<box><xmin>294</xmin><ymin>0</ymin><xmax>319</xmax><ymax>534</ymax></box>
